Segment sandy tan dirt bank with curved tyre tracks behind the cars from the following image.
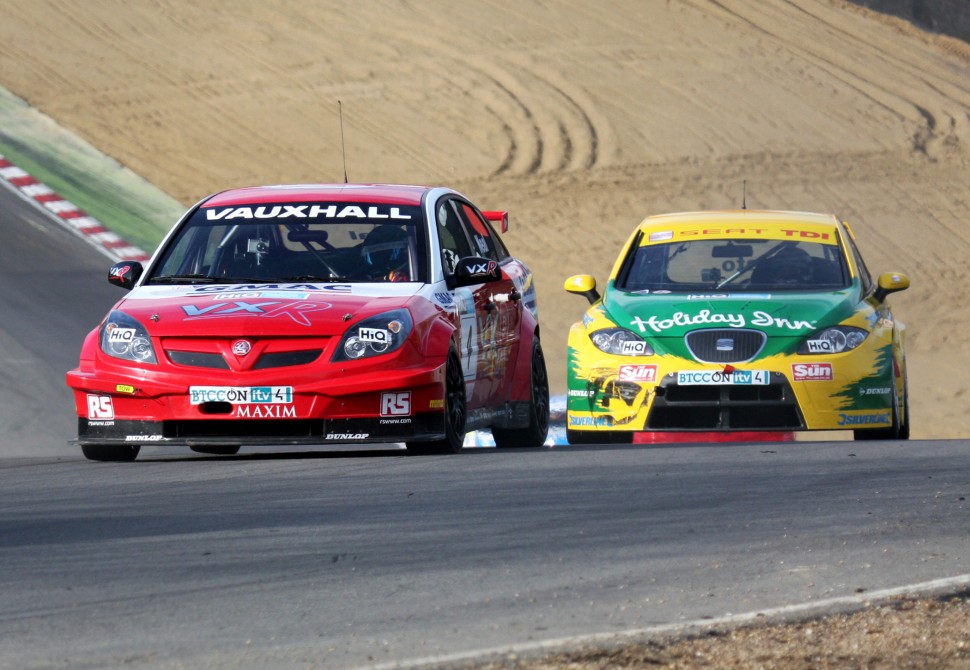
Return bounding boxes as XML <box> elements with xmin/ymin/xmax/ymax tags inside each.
<box><xmin>0</xmin><ymin>0</ymin><xmax>970</xmax><ymax>438</ymax></box>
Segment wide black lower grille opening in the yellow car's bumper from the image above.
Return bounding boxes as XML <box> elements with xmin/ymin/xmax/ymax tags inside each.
<box><xmin>646</xmin><ymin>373</ymin><xmax>805</xmax><ymax>430</ymax></box>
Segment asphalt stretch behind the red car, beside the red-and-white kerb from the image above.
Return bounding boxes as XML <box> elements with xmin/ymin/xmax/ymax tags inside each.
<box><xmin>0</xmin><ymin>180</ymin><xmax>122</xmax><ymax>456</ymax></box>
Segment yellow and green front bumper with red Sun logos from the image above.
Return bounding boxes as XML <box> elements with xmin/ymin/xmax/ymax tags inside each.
<box><xmin>567</xmin><ymin>351</ymin><xmax>901</xmax><ymax>432</ymax></box>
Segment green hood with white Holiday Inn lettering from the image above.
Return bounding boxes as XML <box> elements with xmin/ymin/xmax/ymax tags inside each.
<box><xmin>602</xmin><ymin>286</ymin><xmax>865</xmax><ymax>353</ymax></box>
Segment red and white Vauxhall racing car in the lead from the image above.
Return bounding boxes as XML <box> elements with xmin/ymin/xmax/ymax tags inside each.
<box><xmin>67</xmin><ymin>184</ymin><xmax>549</xmax><ymax>461</ymax></box>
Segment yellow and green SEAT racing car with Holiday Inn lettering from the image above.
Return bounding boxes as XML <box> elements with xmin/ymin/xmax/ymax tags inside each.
<box><xmin>565</xmin><ymin>210</ymin><xmax>909</xmax><ymax>444</ymax></box>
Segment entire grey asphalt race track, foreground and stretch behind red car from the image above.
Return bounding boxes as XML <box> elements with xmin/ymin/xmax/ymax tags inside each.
<box><xmin>0</xmin><ymin>188</ymin><xmax>970</xmax><ymax>669</ymax></box>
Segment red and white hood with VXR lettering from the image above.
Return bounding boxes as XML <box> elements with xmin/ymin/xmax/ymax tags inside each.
<box><xmin>115</xmin><ymin>283</ymin><xmax>422</xmax><ymax>337</ymax></box>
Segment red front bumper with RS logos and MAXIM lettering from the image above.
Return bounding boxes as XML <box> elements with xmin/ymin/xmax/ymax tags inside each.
<box><xmin>67</xmin><ymin>361</ymin><xmax>445</xmax><ymax>447</ymax></box>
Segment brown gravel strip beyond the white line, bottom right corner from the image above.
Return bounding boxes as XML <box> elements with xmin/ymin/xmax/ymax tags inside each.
<box><xmin>452</xmin><ymin>590</ymin><xmax>970</xmax><ymax>670</ymax></box>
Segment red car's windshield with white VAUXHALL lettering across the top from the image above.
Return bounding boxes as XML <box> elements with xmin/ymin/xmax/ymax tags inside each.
<box><xmin>147</xmin><ymin>202</ymin><xmax>427</xmax><ymax>284</ymax></box>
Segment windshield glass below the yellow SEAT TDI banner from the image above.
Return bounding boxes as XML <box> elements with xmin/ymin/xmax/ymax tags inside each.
<box><xmin>616</xmin><ymin>239</ymin><xmax>849</xmax><ymax>293</ymax></box>
